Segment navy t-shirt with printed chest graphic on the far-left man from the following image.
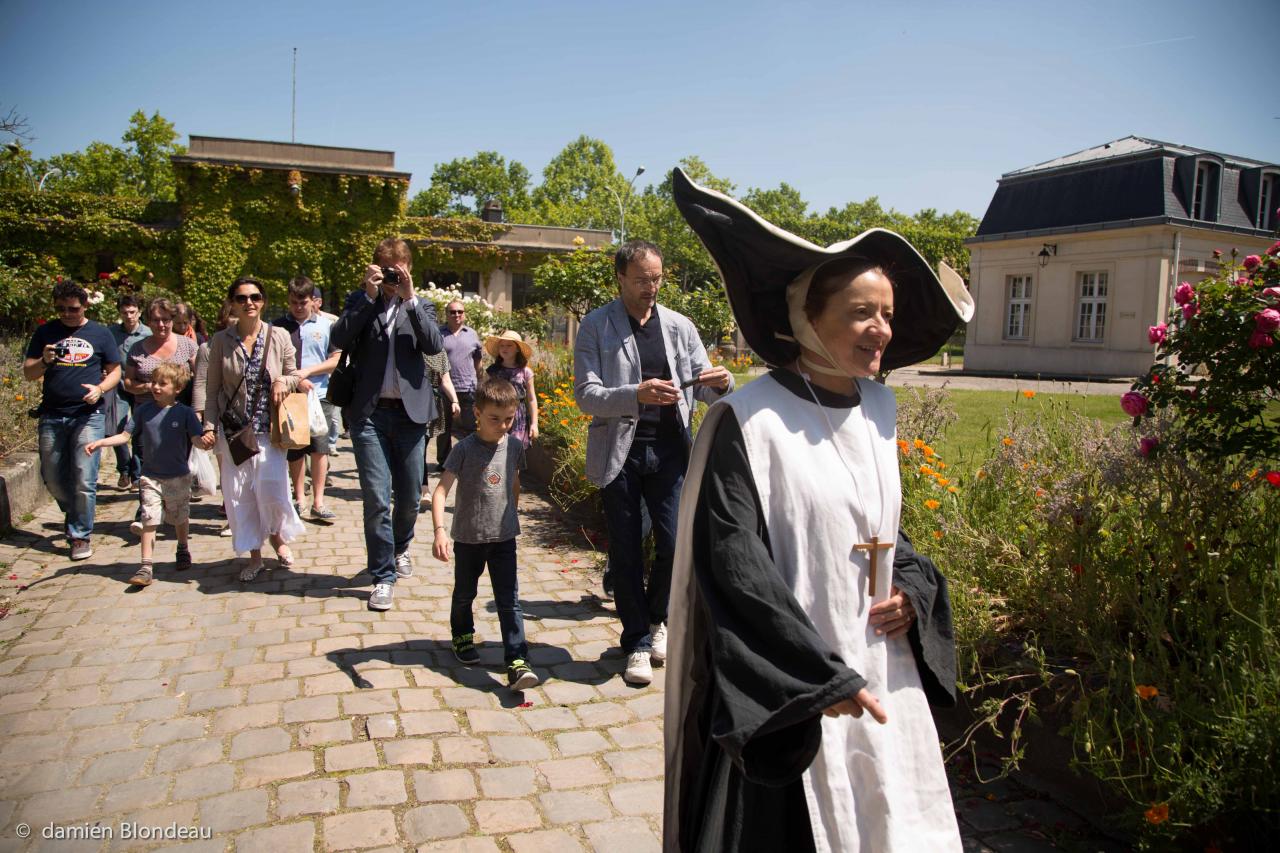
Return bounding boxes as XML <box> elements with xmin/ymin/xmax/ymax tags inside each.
<box><xmin>27</xmin><ymin>320</ymin><xmax>120</xmax><ymax>418</ymax></box>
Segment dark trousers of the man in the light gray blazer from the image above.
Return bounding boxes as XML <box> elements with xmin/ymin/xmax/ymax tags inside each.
<box><xmin>600</xmin><ymin>442</ymin><xmax>689</xmax><ymax>654</ymax></box>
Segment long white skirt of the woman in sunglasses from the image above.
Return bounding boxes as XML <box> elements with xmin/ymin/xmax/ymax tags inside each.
<box><xmin>218</xmin><ymin>430</ymin><xmax>305</xmax><ymax>555</ymax></box>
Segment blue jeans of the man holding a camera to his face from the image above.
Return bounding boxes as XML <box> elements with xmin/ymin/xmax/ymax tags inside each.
<box><xmin>351</xmin><ymin>409</ymin><xmax>426</xmax><ymax>584</ymax></box>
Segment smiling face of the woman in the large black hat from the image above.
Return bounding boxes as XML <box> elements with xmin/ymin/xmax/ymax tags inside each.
<box><xmin>813</xmin><ymin>269</ymin><xmax>893</xmax><ymax>377</ymax></box>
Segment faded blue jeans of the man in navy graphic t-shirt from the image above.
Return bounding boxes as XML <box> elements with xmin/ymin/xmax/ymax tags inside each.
<box><xmin>40</xmin><ymin>411</ymin><xmax>106</xmax><ymax>539</ymax></box>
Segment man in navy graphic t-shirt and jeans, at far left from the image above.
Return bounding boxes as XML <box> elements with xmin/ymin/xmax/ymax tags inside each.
<box><xmin>22</xmin><ymin>282</ymin><xmax>120</xmax><ymax>560</ymax></box>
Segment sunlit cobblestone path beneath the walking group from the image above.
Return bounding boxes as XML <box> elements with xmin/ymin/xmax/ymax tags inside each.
<box><xmin>0</xmin><ymin>442</ymin><xmax>1121</xmax><ymax>853</ymax></box>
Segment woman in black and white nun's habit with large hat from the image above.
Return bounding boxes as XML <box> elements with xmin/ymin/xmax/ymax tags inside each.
<box><xmin>663</xmin><ymin>169</ymin><xmax>973</xmax><ymax>853</ymax></box>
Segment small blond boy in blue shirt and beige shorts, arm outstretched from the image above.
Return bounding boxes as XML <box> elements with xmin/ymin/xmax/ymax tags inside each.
<box><xmin>84</xmin><ymin>362</ymin><xmax>204</xmax><ymax>587</ymax></box>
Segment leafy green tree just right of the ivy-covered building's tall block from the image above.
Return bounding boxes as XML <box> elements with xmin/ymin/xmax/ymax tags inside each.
<box><xmin>408</xmin><ymin>151</ymin><xmax>530</xmax><ymax>220</ymax></box>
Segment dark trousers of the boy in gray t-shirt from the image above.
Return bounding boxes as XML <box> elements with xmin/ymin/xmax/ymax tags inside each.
<box><xmin>449</xmin><ymin>539</ymin><xmax>529</xmax><ymax>663</ymax></box>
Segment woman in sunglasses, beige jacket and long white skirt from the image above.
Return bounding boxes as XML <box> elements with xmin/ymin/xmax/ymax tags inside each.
<box><xmin>193</xmin><ymin>275</ymin><xmax>303</xmax><ymax>583</ymax></box>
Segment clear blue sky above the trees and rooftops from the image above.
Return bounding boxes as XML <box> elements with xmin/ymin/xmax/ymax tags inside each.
<box><xmin>0</xmin><ymin>0</ymin><xmax>1280</xmax><ymax>215</ymax></box>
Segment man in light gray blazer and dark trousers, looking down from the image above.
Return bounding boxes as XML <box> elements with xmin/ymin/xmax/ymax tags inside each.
<box><xmin>573</xmin><ymin>240</ymin><xmax>733</xmax><ymax>684</ymax></box>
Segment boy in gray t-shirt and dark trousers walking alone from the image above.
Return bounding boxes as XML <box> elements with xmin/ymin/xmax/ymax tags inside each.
<box><xmin>431</xmin><ymin>379</ymin><xmax>538</xmax><ymax>690</ymax></box>
